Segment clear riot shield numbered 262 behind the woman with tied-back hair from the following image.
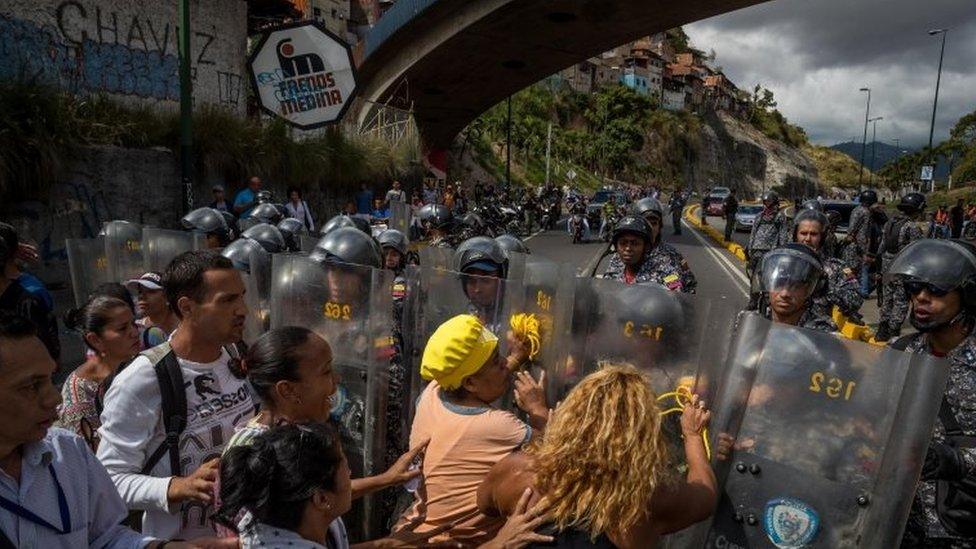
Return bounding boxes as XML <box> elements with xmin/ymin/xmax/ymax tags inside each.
<box><xmin>271</xmin><ymin>254</ymin><xmax>394</xmax><ymax>539</ymax></box>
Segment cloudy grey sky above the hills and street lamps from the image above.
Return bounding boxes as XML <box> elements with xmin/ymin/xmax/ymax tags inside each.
<box><xmin>685</xmin><ymin>0</ymin><xmax>976</xmax><ymax>146</ymax></box>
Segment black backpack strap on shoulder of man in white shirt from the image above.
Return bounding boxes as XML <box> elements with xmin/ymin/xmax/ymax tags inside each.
<box><xmin>142</xmin><ymin>343</ymin><xmax>187</xmax><ymax>476</ymax></box>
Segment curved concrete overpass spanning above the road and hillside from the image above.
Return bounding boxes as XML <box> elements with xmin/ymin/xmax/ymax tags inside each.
<box><xmin>359</xmin><ymin>0</ymin><xmax>767</xmax><ymax>149</ymax></box>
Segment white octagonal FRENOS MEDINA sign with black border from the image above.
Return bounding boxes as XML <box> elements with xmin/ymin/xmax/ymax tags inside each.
<box><xmin>250</xmin><ymin>21</ymin><xmax>356</xmax><ymax>130</ymax></box>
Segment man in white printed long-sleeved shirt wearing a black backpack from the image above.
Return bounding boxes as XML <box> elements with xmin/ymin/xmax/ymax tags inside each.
<box><xmin>98</xmin><ymin>251</ymin><xmax>255</xmax><ymax>539</ymax></box>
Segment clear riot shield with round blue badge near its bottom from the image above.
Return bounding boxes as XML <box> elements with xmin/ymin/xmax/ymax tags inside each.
<box><xmin>701</xmin><ymin>313</ymin><xmax>947</xmax><ymax>548</ymax></box>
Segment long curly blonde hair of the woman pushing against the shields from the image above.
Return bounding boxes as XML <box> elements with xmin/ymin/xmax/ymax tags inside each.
<box><xmin>526</xmin><ymin>364</ymin><xmax>670</xmax><ymax>540</ymax></box>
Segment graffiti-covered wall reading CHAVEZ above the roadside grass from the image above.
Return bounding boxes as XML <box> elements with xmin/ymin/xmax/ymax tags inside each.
<box><xmin>0</xmin><ymin>0</ymin><xmax>248</xmax><ymax>112</ymax></box>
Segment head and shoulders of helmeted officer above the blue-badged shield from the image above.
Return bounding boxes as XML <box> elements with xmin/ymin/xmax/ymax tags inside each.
<box><xmin>759</xmin><ymin>243</ymin><xmax>837</xmax><ymax>332</ymax></box>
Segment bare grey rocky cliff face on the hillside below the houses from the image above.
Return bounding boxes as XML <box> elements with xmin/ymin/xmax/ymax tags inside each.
<box><xmin>685</xmin><ymin>113</ymin><xmax>819</xmax><ymax>197</ymax></box>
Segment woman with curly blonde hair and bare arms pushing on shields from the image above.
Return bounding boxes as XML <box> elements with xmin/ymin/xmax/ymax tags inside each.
<box><xmin>478</xmin><ymin>365</ymin><xmax>718</xmax><ymax>549</ymax></box>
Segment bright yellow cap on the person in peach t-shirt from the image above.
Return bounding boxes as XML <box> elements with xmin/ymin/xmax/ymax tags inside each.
<box><xmin>420</xmin><ymin>315</ymin><xmax>498</xmax><ymax>389</ymax></box>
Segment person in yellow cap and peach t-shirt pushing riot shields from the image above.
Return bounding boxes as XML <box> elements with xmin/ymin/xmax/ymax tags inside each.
<box><xmin>395</xmin><ymin>315</ymin><xmax>549</xmax><ymax>546</ymax></box>
